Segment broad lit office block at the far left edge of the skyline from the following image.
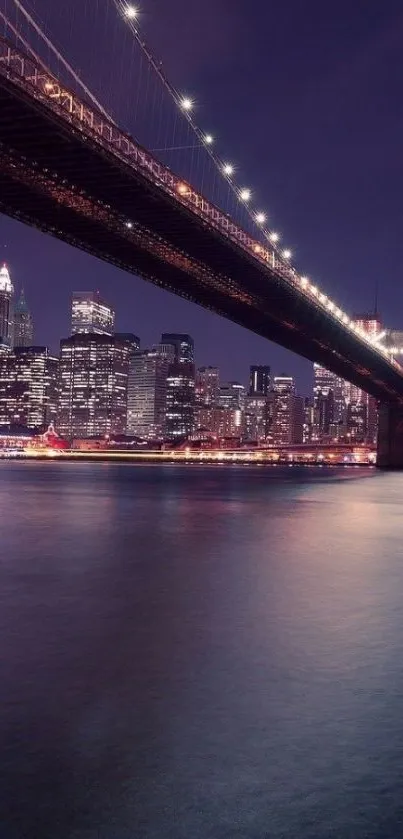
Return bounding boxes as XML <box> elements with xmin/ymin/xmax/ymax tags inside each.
<box><xmin>0</xmin><ymin>347</ymin><xmax>59</xmax><ymax>428</ymax></box>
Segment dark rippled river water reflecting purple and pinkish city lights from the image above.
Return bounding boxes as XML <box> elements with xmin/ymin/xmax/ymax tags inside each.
<box><xmin>0</xmin><ymin>462</ymin><xmax>403</xmax><ymax>839</ymax></box>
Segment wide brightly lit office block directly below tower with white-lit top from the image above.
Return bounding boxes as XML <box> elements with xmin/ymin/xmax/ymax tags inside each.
<box><xmin>58</xmin><ymin>333</ymin><xmax>139</xmax><ymax>438</ymax></box>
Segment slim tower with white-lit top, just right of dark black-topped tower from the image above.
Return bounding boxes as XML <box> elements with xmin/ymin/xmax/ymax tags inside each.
<box><xmin>272</xmin><ymin>376</ymin><xmax>304</xmax><ymax>446</ymax></box>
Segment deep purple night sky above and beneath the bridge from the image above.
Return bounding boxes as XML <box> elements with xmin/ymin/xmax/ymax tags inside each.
<box><xmin>0</xmin><ymin>0</ymin><xmax>403</xmax><ymax>393</ymax></box>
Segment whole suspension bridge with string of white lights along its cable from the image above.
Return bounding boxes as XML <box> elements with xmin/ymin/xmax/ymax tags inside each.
<box><xmin>0</xmin><ymin>0</ymin><xmax>403</xmax><ymax>467</ymax></box>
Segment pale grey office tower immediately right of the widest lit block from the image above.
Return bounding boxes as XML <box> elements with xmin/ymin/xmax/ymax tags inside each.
<box><xmin>127</xmin><ymin>344</ymin><xmax>174</xmax><ymax>440</ymax></box>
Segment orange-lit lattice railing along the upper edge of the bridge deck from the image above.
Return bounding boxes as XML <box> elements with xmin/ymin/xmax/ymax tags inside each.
<box><xmin>0</xmin><ymin>38</ymin><xmax>401</xmax><ymax>369</ymax></box>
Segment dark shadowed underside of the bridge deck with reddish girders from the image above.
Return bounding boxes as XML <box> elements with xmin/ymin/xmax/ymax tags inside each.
<box><xmin>0</xmin><ymin>69</ymin><xmax>403</xmax><ymax>402</ymax></box>
